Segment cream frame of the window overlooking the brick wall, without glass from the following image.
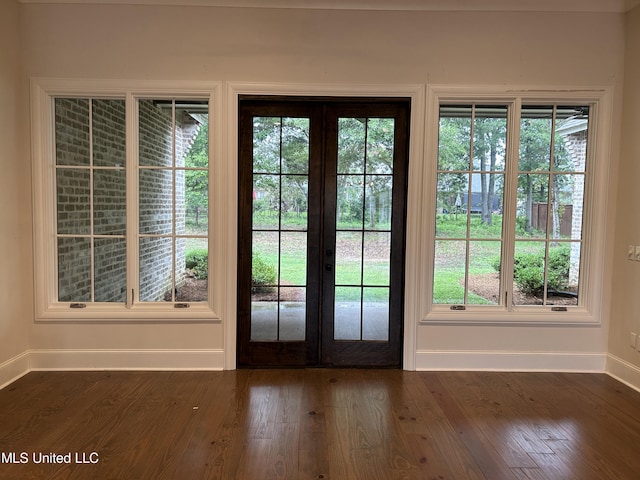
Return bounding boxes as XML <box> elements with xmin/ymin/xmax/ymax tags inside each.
<box><xmin>31</xmin><ymin>78</ymin><xmax>222</xmax><ymax>323</ymax></box>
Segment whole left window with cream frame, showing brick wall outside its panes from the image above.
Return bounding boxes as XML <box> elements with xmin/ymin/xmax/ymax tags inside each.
<box><xmin>34</xmin><ymin>81</ymin><xmax>212</xmax><ymax>319</ymax></box>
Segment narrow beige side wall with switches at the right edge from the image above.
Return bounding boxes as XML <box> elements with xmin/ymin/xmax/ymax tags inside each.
<box><xmin>609</xmin><ymin>3</ymin><xmax>640</xmax><ymax>385</ymax></box>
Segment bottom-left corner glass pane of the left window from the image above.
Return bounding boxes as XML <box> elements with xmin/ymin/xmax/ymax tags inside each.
<box><xmin>58</xmin><ymin>238</ymin><xmax>91</xmax><ymax>302</ymax></box>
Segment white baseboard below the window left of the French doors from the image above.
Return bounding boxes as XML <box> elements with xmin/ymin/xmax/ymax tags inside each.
<box><xmin>29</xmin><ymin>349</ymin><xmax>224</xmax><ymax>370</ymax></box>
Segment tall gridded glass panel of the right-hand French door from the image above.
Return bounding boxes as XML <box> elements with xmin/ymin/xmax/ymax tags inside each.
<box><xmin>334</xmin><ymin>118</ymin><xmax>395</xmax><ymax>341</ymax></box>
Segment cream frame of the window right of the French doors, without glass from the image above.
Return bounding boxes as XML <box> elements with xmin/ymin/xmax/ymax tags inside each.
<box><xmin>420</xmin><ymin>85</ymin><xmax>612</xmax><ymax>325</ymax></box>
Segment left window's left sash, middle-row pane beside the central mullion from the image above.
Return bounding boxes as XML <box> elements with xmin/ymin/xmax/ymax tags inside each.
<box><xmin>93</xmin><ymin>169</ymin><xmax>127</xmax><ymax>235</ymax></box>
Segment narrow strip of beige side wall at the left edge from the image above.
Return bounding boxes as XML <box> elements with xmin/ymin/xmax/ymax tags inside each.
<box><xmin>0</xmin><ymin>0</ymin><xmax>33</xmax><ymax>386</ymax></box>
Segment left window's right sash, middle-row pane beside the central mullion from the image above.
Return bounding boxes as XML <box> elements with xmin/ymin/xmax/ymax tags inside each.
<box><xmin>139</xmin><ymin>169</ymin><xmax>173</xmax><ymax>235</ymax></box>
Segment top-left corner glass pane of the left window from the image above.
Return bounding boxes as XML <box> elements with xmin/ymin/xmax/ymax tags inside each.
<box><xmin>55</xmin><ymin>98</ymin><xmax>91</xmax><ymax>166</ymax></box>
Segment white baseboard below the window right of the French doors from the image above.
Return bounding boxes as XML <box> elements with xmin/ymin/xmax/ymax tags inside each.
<box><xmin>416</xmin><ymin>351</ymin><xmax>607</xmax><ymax>373</ymax></box>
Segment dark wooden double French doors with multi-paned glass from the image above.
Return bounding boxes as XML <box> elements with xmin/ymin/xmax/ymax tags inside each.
<box><xmin>238</xmin><ymin>97</ymin><xmax>410</xmax><ymax>367</ymax></box>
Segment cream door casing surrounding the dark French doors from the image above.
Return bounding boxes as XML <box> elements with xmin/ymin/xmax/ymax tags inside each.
<box><xmin>222</xmin><ymin>82</ymin><xmax>428</xmax><ymax>370</ymax></box>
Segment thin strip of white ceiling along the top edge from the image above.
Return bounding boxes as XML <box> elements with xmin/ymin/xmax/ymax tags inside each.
<box><xmin>19</xmin><ymin>0</ymin><xmax>640</xmax><ymax>13</ymax></box>
